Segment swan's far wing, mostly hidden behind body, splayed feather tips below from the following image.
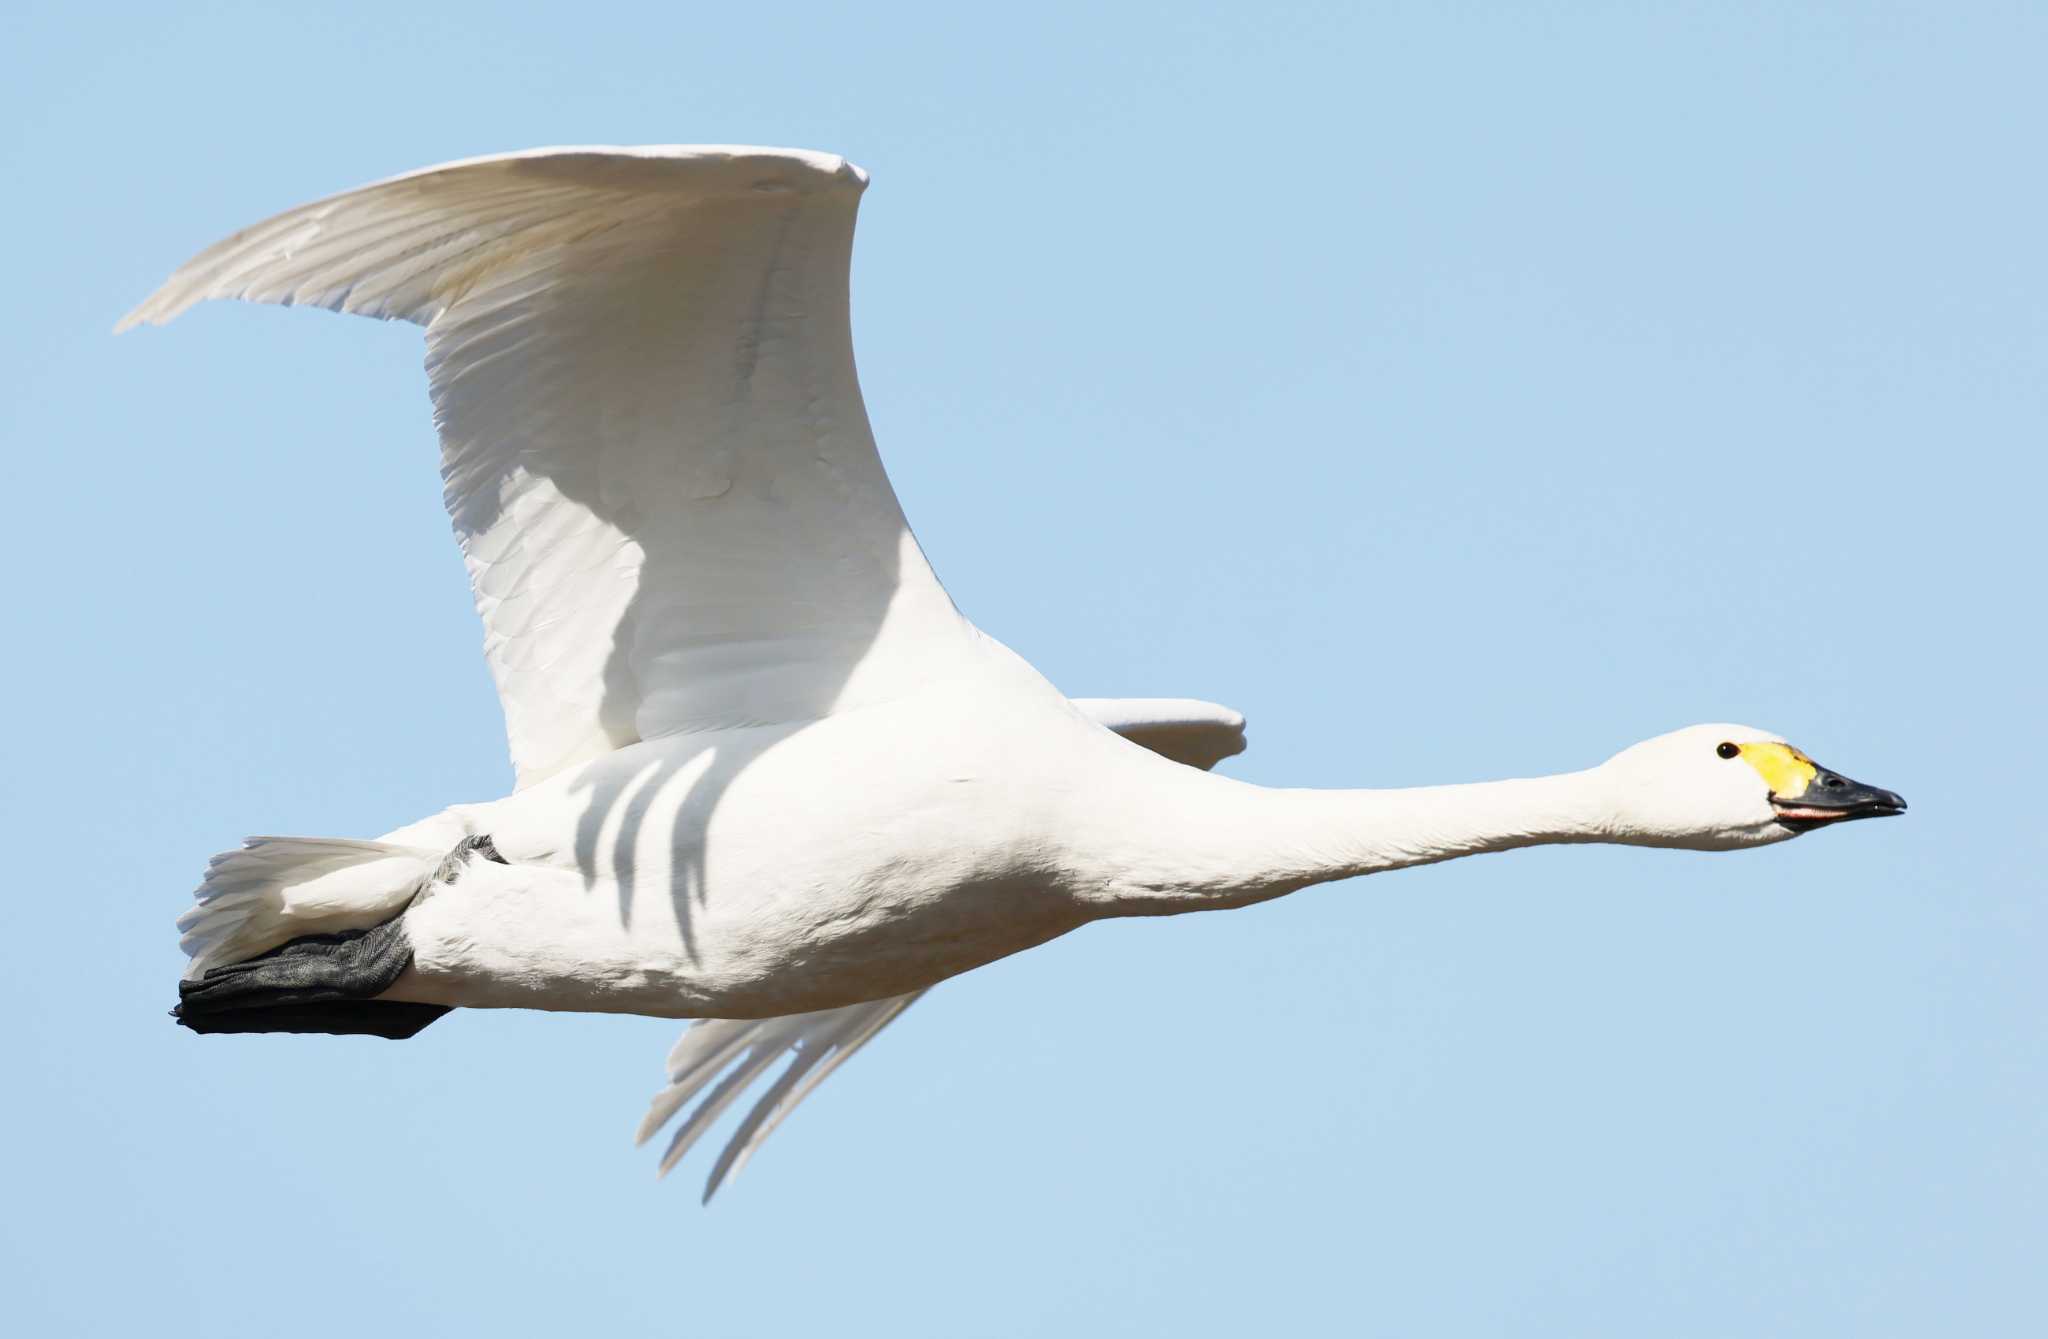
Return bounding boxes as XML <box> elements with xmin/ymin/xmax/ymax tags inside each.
<box><xmin>637</xmin><ymin>698</ymin><xmax>1245</xmax><ymax>1202</ymax></box>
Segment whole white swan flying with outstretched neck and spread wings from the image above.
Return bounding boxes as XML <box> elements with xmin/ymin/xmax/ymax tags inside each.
<box><xmin>121</xmin><ymin>145</ymin><xmax>1905</xmax><ymax>1198</ymax></box>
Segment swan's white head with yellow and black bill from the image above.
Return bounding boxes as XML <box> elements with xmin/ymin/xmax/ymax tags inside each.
<box><xmin>1599</xmin><ymin>725</ymin><xmax>1907</xmax><ymax>852</ymax></box>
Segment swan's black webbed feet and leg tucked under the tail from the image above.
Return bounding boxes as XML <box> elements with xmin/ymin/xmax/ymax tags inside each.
<box><xmin>172</xmin><ymin>835</ymin><xmax>506</xmax><ymax>1040</ymax></box>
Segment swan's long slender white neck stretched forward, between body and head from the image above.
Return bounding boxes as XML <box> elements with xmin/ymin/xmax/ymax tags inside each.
<box><xmin>1100</xmin><ymin>770</ymin><xmax>1618</xmax><ymax>915</ymax></box>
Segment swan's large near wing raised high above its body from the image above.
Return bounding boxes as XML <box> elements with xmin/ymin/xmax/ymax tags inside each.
<box><xmin>121</xmin><ymin>147</ymin><xmax>975</xmax><ymax>786</ymax></box>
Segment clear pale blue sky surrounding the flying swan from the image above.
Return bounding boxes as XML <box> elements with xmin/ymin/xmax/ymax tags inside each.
<box><xmin>0</xmin><ymin>0</ymin><xmax>2048</xmax><ymax>1337</ymax></box>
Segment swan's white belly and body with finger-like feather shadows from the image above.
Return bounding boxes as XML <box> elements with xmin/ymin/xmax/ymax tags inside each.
<box><xmin>387</xmin><ymin>712</ymin><xmax>1114</xmax><ymax>1018</ymax></box>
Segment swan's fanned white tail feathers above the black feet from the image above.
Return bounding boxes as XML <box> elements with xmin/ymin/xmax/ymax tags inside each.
<box><xmin>178</xmin><ymin>837</ymin><xmax>440</xmax><ymax>979</ymax></box>
